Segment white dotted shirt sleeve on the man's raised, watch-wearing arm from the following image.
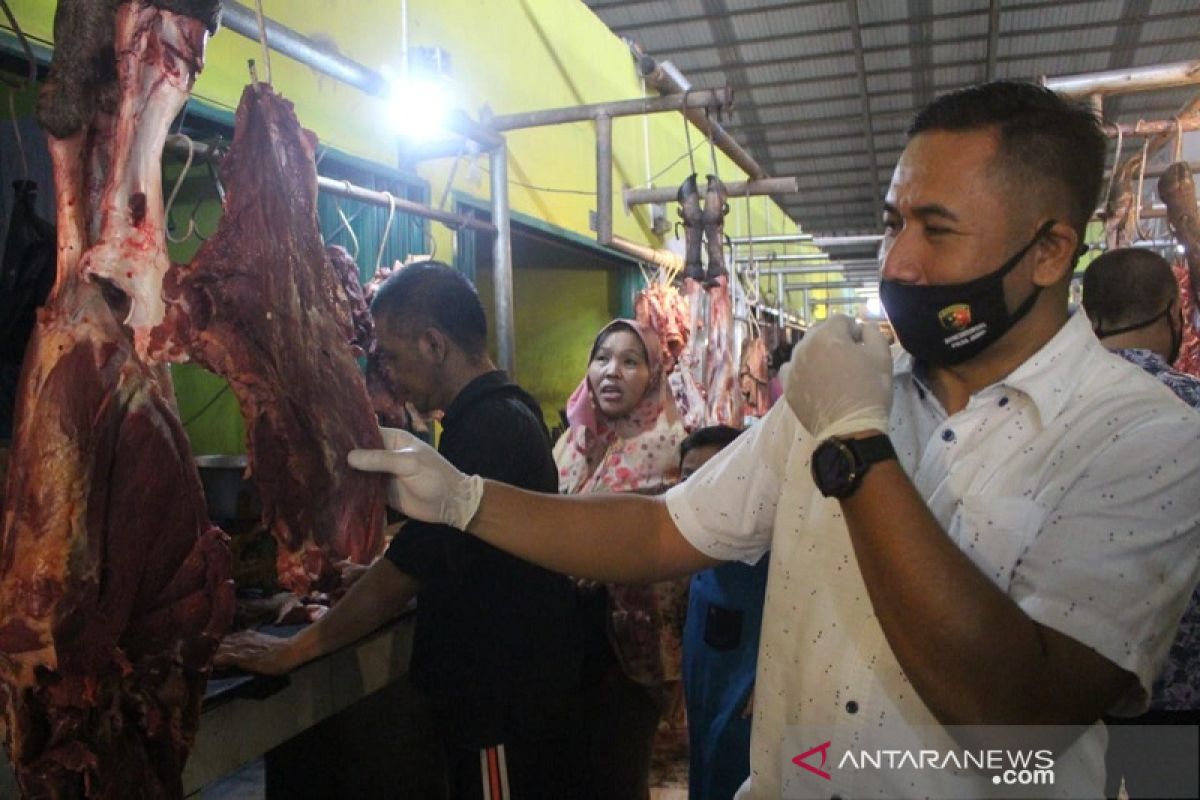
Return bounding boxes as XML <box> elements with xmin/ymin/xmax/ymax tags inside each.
<box><xmin>1009</xmin><ymin>405</ymin><xmax>1200</xmax><ymax>715</ymax></box>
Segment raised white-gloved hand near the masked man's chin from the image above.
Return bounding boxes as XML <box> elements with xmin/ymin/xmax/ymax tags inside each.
<box><xmin>780</xmin><ymin>314</ymin><xmax>892</xmax><ymax>441</ymax></box>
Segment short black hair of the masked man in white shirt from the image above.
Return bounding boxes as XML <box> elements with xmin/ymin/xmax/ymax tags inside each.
<box><xmin>908</xmin><ymin>80</ymin><xmax>1108</xmax><ymax>242</ymax></box>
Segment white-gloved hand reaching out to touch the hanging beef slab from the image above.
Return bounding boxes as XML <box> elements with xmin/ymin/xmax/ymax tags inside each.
<box><xmin>347</xmin><ymin>428</ymin><xmax>484</xmax><ymax>530</ymax></box>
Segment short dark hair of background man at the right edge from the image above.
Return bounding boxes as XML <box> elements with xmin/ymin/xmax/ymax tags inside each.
<box><xmin>1082</xmin><ymin>247</ymin><xmax>1180</xmax><ymax>330</ymax></box>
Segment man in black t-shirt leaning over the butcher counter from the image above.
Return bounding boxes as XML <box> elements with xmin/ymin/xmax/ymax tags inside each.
<box><xmin>224</xmin><ymin>261</ymin><xmax>581</xmax><ymax>799</ymax></box>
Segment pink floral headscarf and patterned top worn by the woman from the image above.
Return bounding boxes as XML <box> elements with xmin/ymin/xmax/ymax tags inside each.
<box><xmin>554</xmin><ymin>319</ymin><xmax>688</xmax><ymax>686</ymax></box>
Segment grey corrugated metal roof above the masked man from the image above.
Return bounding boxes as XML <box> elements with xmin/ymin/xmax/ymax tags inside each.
<box><xmin>584</xmin><ymin>0</ymin><xmax>1200</xmax><ymax>250</ymax></box>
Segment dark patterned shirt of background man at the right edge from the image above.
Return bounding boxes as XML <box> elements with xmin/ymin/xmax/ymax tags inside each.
<box><xmin>1114</xmin><ymin>348</ymin><xmax>1200</xmax><ymax>711</ymax></box>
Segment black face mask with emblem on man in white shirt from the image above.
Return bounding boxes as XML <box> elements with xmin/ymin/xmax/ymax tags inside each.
<box><xmin>880</xmin><ymin>219</ymin><xmax>1055</xmax><ymax>367</ymax></box>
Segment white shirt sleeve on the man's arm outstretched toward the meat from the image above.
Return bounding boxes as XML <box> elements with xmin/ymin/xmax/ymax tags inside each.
<box><xmin>666</xmin><ymin>403</ymin><xmax>808</xmax><ymax>564</ymax></box>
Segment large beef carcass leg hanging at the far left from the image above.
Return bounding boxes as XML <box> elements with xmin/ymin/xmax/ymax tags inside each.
<box><xmin>0</xmin><ymin>0</ymin><xmax>234</xmax><ymax>798</ymax></box>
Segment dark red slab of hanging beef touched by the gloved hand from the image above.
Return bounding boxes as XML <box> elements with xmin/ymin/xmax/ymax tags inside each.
<box><xmin>151</xmin><ymin>84</ymin><xmax>385</xmax><ymax>595</ymax></box>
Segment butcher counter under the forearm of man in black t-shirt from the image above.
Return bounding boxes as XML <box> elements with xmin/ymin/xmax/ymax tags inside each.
<box><xmin>0</xmin><ymin>610</ymin><xmax>413</xmax><ymax>799</ymax></box>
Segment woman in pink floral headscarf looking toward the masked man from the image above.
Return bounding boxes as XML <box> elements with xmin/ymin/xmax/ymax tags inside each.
<box><xmin>554</xmin><ymin>319</ymin><xmax>688</xmax><ymax>800</ymax></box>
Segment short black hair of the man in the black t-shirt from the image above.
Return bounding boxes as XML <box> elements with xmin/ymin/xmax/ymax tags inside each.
<box><xmin>371</xmin><ymin>260</ymin><xmax>487</xmax><ymax>356</ymax></box>
